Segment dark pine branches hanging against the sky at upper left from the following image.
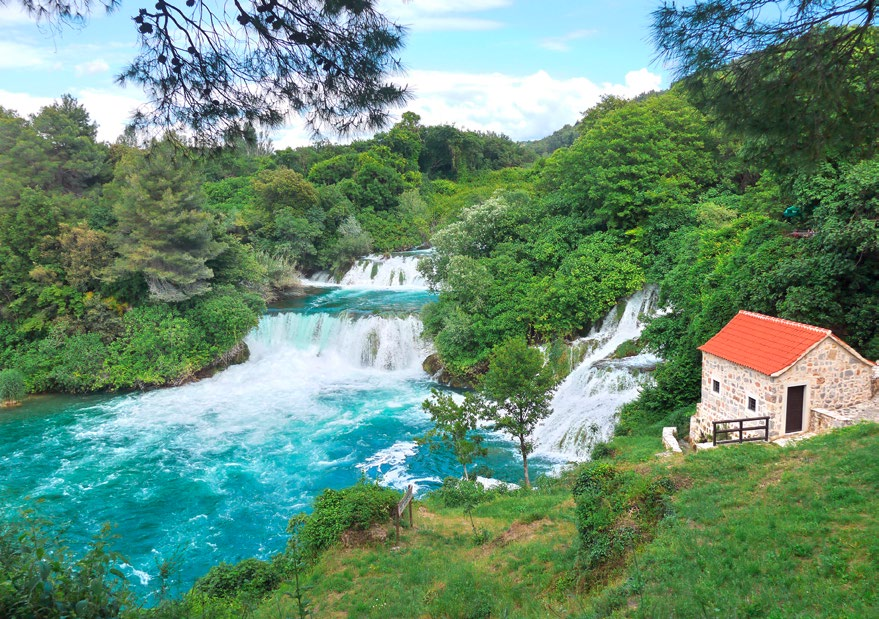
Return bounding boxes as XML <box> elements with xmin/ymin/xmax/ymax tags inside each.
<box><xmin>18</xmin><ymin>0</ymin><xmax>407</xmax><ymax>142</ymax></box>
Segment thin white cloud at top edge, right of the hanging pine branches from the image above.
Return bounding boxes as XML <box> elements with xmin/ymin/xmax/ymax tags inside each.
<box><xmin>379</xmin><ymin>0</ymin><xmax>512</xmax><ymax>31</ymax></box>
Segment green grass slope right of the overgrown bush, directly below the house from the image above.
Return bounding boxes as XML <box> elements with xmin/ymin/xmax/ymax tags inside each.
<box><xmin>584</xmin><ymin>424</ymin><xmax>879</xmax><ymax>617</ymax></box>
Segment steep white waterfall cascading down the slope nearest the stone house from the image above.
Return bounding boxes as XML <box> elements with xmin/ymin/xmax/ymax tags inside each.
<box><xmin>535</xmin><ymin>288</ymin><xmax>658</xmax><ymax>461</ymax></box>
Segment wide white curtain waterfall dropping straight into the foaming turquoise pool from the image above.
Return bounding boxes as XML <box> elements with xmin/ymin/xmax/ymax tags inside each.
<box><xmin>247</xmin><ymin>312</ymin><xmax>430</xmax><ymax>370</ymax></box>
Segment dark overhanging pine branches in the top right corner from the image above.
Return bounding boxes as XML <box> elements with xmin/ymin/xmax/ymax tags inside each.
<box><xmin>653</xmin><ymin>0</ymin><xmax>879</xmax><ymax>170</ymax></box>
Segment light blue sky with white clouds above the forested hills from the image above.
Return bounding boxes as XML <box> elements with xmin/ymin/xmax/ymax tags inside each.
<box><xmin>0</xmin><ymin>0</ymin><xmax>669</xmax><ymax>148</ymax></box>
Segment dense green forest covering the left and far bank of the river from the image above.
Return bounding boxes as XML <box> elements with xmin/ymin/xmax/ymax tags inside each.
<box><xmin>0</xmin><ymin>97</ymin><xmax>535</xmax><ymax>393</ymax></box>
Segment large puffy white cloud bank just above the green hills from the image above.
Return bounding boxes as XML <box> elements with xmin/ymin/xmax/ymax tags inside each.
<box><xmin>396</xmin><ymin>69</ymin><xmax>662</xmax><ymax>140</ymax></box>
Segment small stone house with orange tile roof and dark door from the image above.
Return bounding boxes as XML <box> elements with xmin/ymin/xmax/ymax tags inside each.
<box><xmin>690</xmin><ymin>311</ymin><xmax>879</xmax><ymax>442</ymax></box>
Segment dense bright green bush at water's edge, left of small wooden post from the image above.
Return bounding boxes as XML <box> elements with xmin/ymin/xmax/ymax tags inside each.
<box><xmin>291</xmin><ymin>480</ymin><xmax>400</xmax><ymax>558</ymax></box>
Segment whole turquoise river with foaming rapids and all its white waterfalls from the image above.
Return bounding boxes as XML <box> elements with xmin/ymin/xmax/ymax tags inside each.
<box><xmin>0</xmin><ymin>255</ymin><xmax>649</xmax><ymax>593</ymax></box>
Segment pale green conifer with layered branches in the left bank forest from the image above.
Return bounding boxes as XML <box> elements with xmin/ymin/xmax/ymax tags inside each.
<box><xmin>113</xmin><ymin>141</ymin><xmax>223</xmax><ymax>301</ymax></box>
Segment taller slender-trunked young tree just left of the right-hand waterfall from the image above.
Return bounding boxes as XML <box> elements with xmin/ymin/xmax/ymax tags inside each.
<box><xmin>480</xmin><ymin>338</ymin><xmax>555</xmax><ymax>488</ymax></box>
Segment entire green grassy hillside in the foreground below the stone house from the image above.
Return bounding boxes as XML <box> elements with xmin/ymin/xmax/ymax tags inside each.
<box><xmin>230</xmin><ymin>424</ymin><xmax>879</xmax><ymax>618</ymax></box>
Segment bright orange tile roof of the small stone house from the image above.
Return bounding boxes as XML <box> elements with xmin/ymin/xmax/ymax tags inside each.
<box><xmin>699</xmin><ymin>310</ymin><xmax>836</xmax><ymax>376</ymax></box>
